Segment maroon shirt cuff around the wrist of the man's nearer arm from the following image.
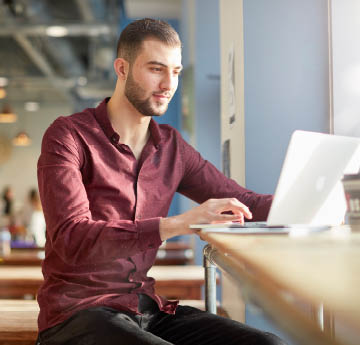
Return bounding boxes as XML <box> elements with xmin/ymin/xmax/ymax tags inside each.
<box><xmin>136</xmin><ymin>218</ymin><xmax>162</xmax><ymax>251</ymax></box>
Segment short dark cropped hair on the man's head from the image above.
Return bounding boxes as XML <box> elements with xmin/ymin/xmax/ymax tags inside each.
<box><xmin>117</xmin><ymin>18</ymin><xmax>181</xmax><ymax>63</ymax></box>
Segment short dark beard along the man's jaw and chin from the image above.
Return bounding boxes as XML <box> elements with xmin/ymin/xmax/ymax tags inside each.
<box><xmin>125</xmin><ymin>70</ymin><xmax>168</xmax><ymax>116</ymax></box>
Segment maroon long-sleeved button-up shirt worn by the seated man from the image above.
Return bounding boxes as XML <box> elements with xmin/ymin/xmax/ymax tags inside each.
<box><xmin>38</xmin><ymin>100</ymin><xmax>272</xmax><ymax>331</ymax></box>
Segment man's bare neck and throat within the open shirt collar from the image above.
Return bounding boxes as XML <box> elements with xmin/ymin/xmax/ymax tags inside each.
<box><xmin>107</xmin><ymin>96</ymin><xmax>151</xmax><ymax>159</ymax></box>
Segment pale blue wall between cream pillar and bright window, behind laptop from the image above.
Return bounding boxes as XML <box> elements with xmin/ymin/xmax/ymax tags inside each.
<box><xmin>243</xmin><ymin>0</ymin><xmax>329</xmax><ymax>193</ymax></box>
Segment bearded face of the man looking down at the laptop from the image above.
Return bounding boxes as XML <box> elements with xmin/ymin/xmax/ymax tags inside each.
<box><xmin>125</xmin><ymin>40</ymin><xmax>182</xmax><ymax>116</ymax></box>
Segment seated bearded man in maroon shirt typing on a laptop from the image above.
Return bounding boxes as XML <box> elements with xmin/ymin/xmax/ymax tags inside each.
<box><xmin>38</xmin><ymin>19</ymin><xmax>282</xmax><ymax>345</ymax></box>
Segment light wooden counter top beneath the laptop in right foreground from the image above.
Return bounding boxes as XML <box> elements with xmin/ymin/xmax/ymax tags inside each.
<box><xmin>201</xmin><ymin>227</ymin><xmax>360</xmax><ymax>344</ymax></box>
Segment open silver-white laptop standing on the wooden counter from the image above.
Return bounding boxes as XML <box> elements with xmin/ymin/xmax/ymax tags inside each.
<box><xmin>191</xmin><ymin>130</ymin><xmax>360</xmax><ymax>233</ymax></box>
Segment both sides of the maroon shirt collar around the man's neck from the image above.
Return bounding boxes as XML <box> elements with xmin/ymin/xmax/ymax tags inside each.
<box><xmin>94</xmin><ymin>97</ymin><xmax>161</xmax><ymax>147</ymax></box>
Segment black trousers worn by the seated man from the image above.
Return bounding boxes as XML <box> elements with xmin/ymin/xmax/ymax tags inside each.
<box><xmin>38</xmin><ymin>295</ymin><xmax>285</xmax><ymax>345</ymax></box>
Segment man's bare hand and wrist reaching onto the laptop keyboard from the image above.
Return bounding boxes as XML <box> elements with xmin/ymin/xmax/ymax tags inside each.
<box><xmin>160</xmin><ymin>198</ymin><xmax>252</xmax><ymax>241</ymax></box>
